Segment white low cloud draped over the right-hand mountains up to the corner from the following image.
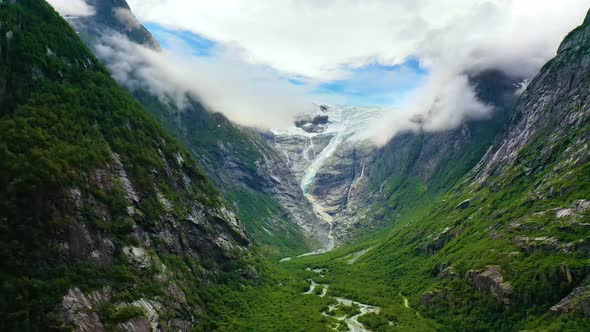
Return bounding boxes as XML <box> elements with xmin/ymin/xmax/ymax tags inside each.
<box><xmin>372</xmin><ymin>1</ymin><xmax>587</xmax><ymax>144</ymax></box>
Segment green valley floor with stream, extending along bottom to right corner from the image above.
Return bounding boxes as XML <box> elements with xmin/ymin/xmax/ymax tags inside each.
<box><xmin>206</xmin><ymin>206</ymin><xmax>590</xmax><ymax>332</ymax></box>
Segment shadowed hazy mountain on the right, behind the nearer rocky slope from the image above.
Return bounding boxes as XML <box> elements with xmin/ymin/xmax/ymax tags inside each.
<box><xmin>357</xmin><ymin>69</ymin><xmax>523</xmax><ymax>236</ymax></box>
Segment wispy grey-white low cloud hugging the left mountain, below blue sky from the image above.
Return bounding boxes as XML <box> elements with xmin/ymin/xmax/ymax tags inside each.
<box><xmin>95</xmin><ymin>32</ymin><xmax>324</xmax><ymax>129</ymax></box>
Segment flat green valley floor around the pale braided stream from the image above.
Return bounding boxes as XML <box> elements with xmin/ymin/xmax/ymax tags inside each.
<box><xmin>206</xmin><ymin>243</ymin><xmax>437</xmax><ymax>332</ymax></box>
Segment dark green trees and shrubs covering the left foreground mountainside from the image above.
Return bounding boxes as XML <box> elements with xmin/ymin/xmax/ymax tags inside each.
<box><xmin>0</xmin><ymin>0</ymin><xmax>247</xmax><ymax>331</ymax></box>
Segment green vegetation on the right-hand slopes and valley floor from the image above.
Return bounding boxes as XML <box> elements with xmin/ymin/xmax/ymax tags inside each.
<box><xmin>198</xmin><ymin>22</ymin><xmax>590</xmax><ymax>331</ymax></box>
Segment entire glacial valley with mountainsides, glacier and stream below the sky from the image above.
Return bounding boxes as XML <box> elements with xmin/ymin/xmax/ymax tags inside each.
<box><xmin>0</xmin><ymin>0</ymin><xmax>590</xmax><ymax>332</ymax></box>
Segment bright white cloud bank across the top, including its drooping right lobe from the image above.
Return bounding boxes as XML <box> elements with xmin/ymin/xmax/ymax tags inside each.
<box><xmin>129</xmin><ymin>0</ymin><xmax>588</xmax><ymax>142</ymax></box>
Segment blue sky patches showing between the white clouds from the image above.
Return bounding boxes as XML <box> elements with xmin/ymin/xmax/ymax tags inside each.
<box><xmin>144</xmin><ymin>23</ymin><xmax>428</xmax><ymax>107</ymax></box>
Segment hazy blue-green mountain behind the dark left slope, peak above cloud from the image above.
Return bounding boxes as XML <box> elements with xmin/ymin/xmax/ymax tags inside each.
<box><xmin>68</xmin><ymin>0</ymin><xmax>327</xmax><ymax>257</ymax></box>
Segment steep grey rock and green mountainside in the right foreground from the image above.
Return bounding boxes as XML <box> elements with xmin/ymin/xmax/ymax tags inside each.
<box><xmin>386</xmin><ymin>13</ymin><xmax>590</xmax><ymax>330</ymax></box>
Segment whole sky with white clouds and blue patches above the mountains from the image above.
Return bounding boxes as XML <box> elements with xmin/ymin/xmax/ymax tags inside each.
<box><xmin>50</xmin><ymin>0</ymin><xmax>590</xmax><ymax>142</ymax></box>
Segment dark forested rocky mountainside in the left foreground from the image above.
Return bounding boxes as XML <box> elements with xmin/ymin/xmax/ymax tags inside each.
<box><xmin>0</xmin><ymin>0</ymin><xmax>252</xmax><ymax>331</ymax></box>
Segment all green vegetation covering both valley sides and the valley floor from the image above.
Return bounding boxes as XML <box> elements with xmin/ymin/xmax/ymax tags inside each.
<box><xmin>0</xmin><ymin>0</ymin><xmax>590</xmax><ymax>331</ymax></box>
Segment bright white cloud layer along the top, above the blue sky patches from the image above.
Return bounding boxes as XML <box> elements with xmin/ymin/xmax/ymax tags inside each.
<box><xmin>129</xmin><ymin>0</ymin><xmax>588</xmax><ymax>80</ymax></box>
